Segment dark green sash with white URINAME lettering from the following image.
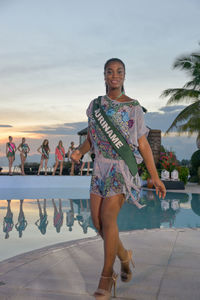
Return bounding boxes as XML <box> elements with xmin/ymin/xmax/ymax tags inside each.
<box><xmin>93</xmin><ymin>96</ymin><xmax>138</xmax><ymax>176</ymax></box>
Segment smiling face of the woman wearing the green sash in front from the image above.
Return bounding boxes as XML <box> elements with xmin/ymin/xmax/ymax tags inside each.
<box><xmin>104</xmin><ymin>61</ymin><xmax>125</xmax><ymax>89</ymax></box>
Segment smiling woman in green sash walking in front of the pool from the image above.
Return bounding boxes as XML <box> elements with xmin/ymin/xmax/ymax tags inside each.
<box><xmin>71</xmin><ymin>58</ymin><xmax>166</xmax><ymax>300</ymax></box>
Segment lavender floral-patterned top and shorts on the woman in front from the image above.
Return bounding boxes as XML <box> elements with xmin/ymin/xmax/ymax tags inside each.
<box><xmin>87</xmin><ymin>96</ymin><xmax>149</xmax><ymax>202</ymax></box>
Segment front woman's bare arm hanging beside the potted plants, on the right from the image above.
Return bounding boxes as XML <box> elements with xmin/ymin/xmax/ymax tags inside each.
<box><xmin>138</xmin><ymin>135</ymin><xmax>166</xmax><ymax>198</ymax></box>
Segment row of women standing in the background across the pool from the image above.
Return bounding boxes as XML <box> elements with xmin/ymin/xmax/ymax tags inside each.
<box><xmin>6</xmin><ymin>136</ymin><xmax>92</xmax><ymax>176</ymax></box>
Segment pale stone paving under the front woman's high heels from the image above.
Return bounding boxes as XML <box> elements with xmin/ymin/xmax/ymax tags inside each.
<box><xmin>0</xmin><ymin>229</ymin><xmax>200</xmax><ymax>300</ymax></box>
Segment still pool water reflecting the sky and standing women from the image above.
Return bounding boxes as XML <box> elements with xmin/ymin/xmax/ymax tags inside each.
<box><xmin>0</xmin><ymin>190</ymin><xmax>200</xmax><ymax>261</ymax></box>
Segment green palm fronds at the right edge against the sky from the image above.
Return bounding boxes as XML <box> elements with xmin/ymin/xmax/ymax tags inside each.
<box><xmin>161</xmin><ymin>46</ymin><xmax>200</xmax><ymax>148</ymax></box>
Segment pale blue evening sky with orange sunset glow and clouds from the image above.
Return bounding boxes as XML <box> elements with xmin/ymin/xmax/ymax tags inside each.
<box><xmin>0</xmin><ymin>0</ymin><xmax>200</xmax><ymax>165</ymax></box>
